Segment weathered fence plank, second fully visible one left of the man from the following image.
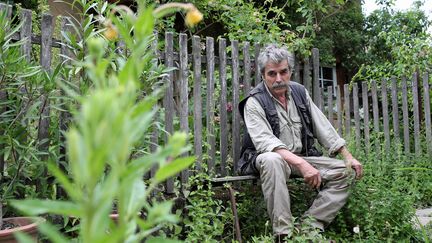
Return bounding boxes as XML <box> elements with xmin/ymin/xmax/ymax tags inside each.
<box><xmin>219</xmin><ymin>38</ymin><xmax>229</xmax><ymax>176</ymax></box>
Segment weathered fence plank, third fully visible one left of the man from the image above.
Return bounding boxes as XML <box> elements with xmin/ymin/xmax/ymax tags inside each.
<box><xmin>206</xmin><ymin>37</ymin><xmax>216</xmax><ymax>173</ymax></box>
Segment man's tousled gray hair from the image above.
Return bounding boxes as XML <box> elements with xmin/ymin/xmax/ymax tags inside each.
<box><xmin>258</xmin><ymin>44</ymin><xmax>293</xmax><ymax>74</ymax></box>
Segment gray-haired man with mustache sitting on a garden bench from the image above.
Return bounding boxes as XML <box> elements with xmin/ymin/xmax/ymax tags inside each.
<box><xmin>237</xmin><ymin>45</ymin><xmax>363</xmax><ymax>236</ymax></box>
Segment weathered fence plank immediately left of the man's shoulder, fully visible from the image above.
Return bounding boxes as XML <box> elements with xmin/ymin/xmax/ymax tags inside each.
<box><xmin>231</xmin><ymin>40</ymin><xmax>241</xmax><ymax>168</ymax></box>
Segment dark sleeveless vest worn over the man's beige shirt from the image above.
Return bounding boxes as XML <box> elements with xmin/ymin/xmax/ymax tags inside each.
<box><xmin>236</xmin><ymin>81</ymin><xmax>322</xmax><ymax>175</ymax></box>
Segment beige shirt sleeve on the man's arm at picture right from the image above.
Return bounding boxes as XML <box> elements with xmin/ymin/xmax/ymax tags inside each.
<box><xmin>306</xmin><ymin>89</ymin><xmax>346</xmax><ymax>156</ymax></box>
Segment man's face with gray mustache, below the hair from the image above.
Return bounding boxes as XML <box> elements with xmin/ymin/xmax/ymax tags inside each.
<box><xmin>263</xmin><ymin>60</ymin><xmax>291</xmax><ymax>97</ymax></box>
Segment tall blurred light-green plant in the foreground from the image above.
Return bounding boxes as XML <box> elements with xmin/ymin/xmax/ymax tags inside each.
<box><xmin>13</xmin><ymin>0</ymin><xmax>202</xmax><ymax>242</ymax></box>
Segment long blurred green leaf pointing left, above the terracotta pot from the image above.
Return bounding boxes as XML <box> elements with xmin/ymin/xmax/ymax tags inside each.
<box><xmin>10</xmin><ymin>199</ymin><xmax>81</xmax><ymax>217</ymax></box>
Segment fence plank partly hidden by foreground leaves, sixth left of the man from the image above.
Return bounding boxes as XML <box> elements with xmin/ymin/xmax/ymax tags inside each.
<box><xmin>163</xmin><ymin>32</ymin><xmax>175</xmax><ymax>194</ymax></box>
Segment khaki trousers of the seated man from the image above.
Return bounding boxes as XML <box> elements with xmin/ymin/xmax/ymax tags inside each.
<box><xmin>255</xmin><ymin>152</ymin><xmax>350</xmax><ymax>234</ymax></box>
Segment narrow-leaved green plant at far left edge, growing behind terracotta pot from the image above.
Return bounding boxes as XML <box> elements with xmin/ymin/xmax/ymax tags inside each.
<box><xmin>0</xmin><ymin>7</ymin><xmax>52</xmax><ymax>227</ymax></box>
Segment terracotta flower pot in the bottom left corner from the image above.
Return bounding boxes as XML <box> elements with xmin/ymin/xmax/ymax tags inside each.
<box><xmin>0</xmin><ymin>217</ymin><xmax>45</xmax><ymax>243</ymax></box>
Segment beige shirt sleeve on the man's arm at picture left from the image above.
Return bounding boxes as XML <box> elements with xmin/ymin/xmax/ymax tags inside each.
<box><xmin>244</xmin><ymin>97</ymin><xmax>286</xmax><ymax>153</ymax></box>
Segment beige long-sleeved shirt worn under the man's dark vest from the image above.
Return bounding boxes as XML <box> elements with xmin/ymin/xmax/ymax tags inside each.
<box><xmin>244</xmin><ymin>81</ymin><xmax>346</xmax><ymax>155</ymax></box>
